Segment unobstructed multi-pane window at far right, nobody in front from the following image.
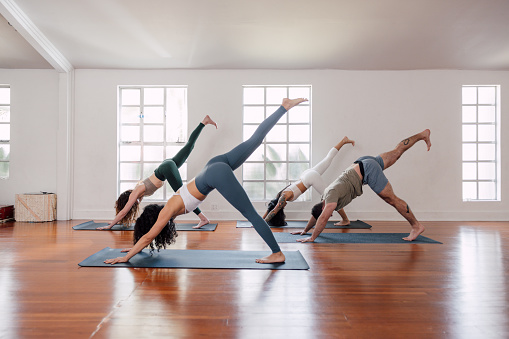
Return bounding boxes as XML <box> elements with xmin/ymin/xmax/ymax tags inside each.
<box><xmin>462</xmin><ymin>86</ymin><xmax>501</xmax><ymax>201</ymax></box>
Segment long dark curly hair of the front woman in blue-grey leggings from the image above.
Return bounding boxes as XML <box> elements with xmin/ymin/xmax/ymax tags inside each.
<box><xmin>133</xmin><ymin>204</ymin><xmax>178</xmax><ymax>253</ymax></box>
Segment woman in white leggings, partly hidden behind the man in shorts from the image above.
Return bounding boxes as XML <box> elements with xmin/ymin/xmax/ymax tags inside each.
<box><xmin>263</xmin><ymin>137</ymin><xmax>355</xmax><ymax>226</ymax></box>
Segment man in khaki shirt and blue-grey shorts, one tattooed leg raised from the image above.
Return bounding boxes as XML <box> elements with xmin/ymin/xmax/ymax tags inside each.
<box><xmin>292</xmin><ymin>129</ymin><xmax>431</xmax><ymax>242</ymax></box>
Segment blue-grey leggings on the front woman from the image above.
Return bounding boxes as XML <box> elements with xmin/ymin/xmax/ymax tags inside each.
<box><xmin>195</xmin><ymin>106</ymin><xmax>286</xmax><ymax>253</ymax></box>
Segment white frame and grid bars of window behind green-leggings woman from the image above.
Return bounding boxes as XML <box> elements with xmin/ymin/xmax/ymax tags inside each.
<box><xmin>117</xmin><ymin>85</ymin><xmax>189</xmax><ymax>202</ymax></box>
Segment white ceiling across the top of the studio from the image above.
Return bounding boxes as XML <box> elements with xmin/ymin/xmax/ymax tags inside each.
<box><xmin>0</xmin><ymin>0</ymin><xmax>509</xmax><ymax>71</ymax></box>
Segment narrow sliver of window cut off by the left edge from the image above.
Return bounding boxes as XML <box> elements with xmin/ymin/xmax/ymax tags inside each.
<box><xmin>0</xmin><ymin>85</ymin><xmax>11</xmax><ymax>179</ymax></box>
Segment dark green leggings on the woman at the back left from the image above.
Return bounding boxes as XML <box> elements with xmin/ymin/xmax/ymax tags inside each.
<box><xmin>154</xmin><ymin>122</ymin><xmax>205</xmax><ymax>215</ymax></box>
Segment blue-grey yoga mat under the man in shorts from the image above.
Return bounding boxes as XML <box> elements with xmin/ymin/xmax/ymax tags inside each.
<box><xmin>274</xmin><ymin>232</ymin><xmax>441</xmax><ymax>244</ymax></box>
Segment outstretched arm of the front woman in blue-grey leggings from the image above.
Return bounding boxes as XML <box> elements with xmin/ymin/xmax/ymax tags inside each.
<box><xmin>104</xmin><ymin>196</ymin><xmax>183</xmax><ymax>265</ymax></box>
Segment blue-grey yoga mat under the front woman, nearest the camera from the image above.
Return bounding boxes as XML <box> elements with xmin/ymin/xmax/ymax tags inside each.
<box><xmin>78</xmin><ymin>247</ymin><xmax>309</xmax><ymax>270</ymax></box>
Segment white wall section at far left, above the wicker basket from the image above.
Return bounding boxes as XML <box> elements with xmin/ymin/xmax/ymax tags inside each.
<box><xmin>0</xmin><ymin>69</ymin><xmax>59</xmax><ymax>205</ymax></box>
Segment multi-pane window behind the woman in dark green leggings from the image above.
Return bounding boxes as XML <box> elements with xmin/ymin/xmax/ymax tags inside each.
<box><xmin>118</xmin><ymin>86</ymin><xmax>187</xmax><ymax>201</ymax></box>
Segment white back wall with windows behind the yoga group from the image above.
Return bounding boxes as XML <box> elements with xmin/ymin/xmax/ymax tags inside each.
<box><xmin>74</xmin><ymin>70</ymin><xmax>509</xmax><ymax>220</ymax></box>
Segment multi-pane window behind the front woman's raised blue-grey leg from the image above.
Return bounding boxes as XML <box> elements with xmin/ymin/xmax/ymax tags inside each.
<box><xmin>242</xmin><ymin>86</ymin><xmax>311</xmax><ymax>201</ymax></box>
